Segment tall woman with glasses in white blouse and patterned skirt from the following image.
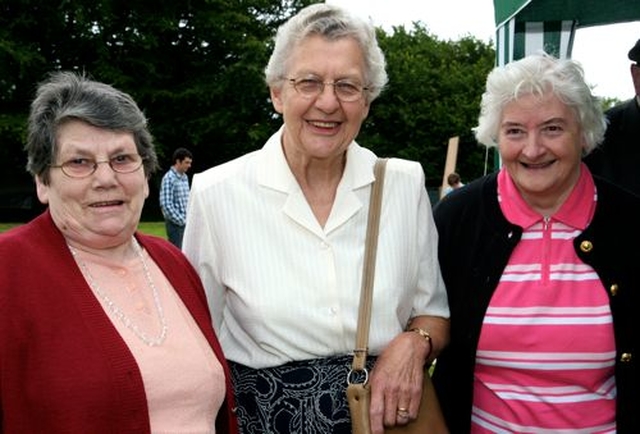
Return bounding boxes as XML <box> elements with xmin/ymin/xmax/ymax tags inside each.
<box><xmin>183</xmin><ymin>3</ymin><xmax>449</xmax><ymax>434</ymax></box>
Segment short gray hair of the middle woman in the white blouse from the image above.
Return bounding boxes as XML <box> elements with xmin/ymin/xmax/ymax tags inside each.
<box><xmin>265</xmin><ymin>3</ymin><xmax>388</xmax><ymax>102</ymax></box>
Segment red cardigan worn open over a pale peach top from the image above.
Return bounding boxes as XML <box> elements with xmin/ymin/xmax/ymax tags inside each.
<box><xmin>0</xmin><ymin>211</ymin><xmax>238</xmax><ymax>434</ymax></box>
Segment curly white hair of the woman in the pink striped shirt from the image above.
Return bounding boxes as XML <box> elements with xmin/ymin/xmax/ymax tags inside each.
<box><xmin>475</xmin><ymin>52</ymin><xmax>607</xmax><ymax>155</ymax></box>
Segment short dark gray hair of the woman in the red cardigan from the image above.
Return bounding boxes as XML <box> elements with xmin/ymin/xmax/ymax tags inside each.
<box><xmin>25</xmin><ymin>71</ymin><xmax>158</xmax><ymax>184</ymax></box>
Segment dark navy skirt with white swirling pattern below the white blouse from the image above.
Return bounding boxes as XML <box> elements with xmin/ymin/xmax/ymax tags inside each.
<box><xmin>229</xmin><ymin>356</ymin><xmax>375</xmax><ymax>434</ymax></box>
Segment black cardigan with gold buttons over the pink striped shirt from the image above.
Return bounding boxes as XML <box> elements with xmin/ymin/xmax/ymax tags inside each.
<box><xmin>434</xmin><ymin>173</ymin><xmax>640</xmax><ymax>434</ymax></box>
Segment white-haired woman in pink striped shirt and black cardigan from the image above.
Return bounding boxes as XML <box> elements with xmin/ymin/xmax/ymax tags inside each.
<box><xmin>433</xmin><ymin>53</ymin><xmax>640</xmax><ymax>434</ymax></box>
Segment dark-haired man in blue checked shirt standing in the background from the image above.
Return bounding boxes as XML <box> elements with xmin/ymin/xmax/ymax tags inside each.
<box><xmin>160</xmin><ymin>148</ymin><xmax>193</xmax><ymax>248</ymax></box>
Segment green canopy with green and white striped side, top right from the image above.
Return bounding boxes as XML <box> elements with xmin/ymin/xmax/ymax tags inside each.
<box><xmin>493</xmin><ymin>0</ymin><xmax>640</xmax><ymax>65</ymax></box>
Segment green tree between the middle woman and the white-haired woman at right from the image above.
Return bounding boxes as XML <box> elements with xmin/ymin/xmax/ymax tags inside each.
<box><xmin>359</xmin><ymin>24</ymin><xmax>495</xmax><ymax>186</ymax></box>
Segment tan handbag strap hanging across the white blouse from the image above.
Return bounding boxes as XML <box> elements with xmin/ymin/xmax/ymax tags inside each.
<box><xmin>351</xmin><ymin>158</ymin><xmax>388</xmax><ymax>371</ymax></box>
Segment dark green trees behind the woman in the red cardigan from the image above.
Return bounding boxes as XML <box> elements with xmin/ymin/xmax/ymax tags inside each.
<box><xmin>0</xmin><ymin>0</ymin><xmax>311</xmax><ymax>217</ymax></box>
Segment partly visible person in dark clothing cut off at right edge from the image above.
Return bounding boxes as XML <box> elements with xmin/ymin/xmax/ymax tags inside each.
<box><xmin>584</xmin><ymin>39</ymin><xmax>640</xmax><ymax>196</ymax></box>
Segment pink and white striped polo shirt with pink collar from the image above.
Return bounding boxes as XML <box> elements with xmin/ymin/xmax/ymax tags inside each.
<box><xmin>471</xmin><ymin>167</ymin><xmax>616</xmax><ymax>433</ymax></box>
